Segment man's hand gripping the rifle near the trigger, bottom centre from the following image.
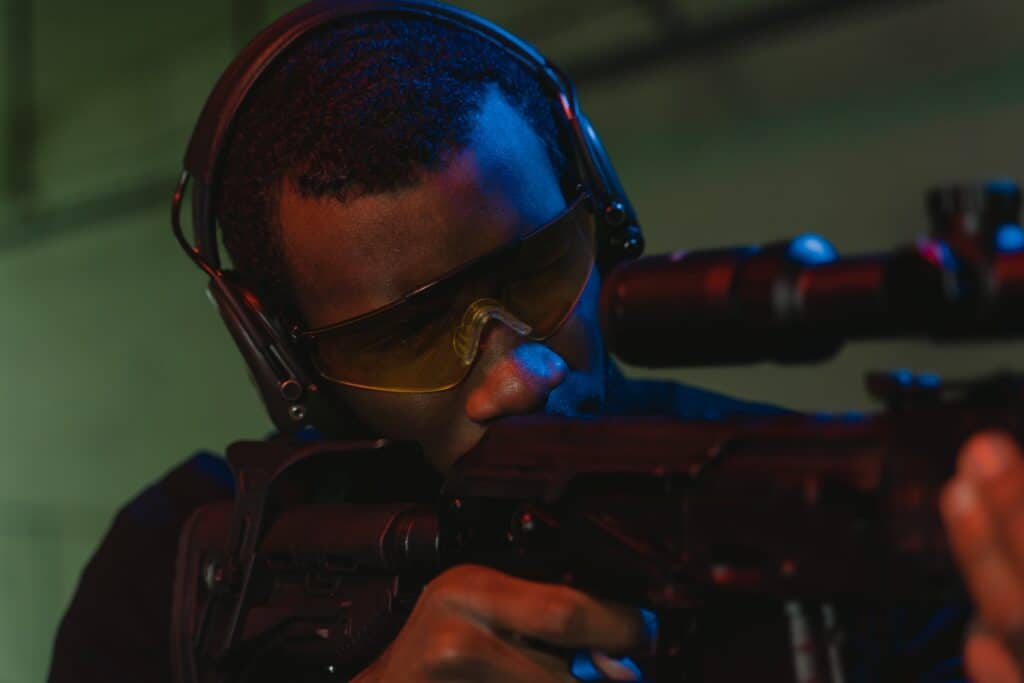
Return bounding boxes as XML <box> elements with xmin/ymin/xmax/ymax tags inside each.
<box><xmin>355</xmin><ymin>565</ymin><xmax>647</xmax><ymax>683</ymax></box>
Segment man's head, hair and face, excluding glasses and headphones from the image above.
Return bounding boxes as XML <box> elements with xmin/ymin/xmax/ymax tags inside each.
<box><xmin>218</xmin><ymin>14</ymin><xmax>604</xmax><ymax>468</ymax></box>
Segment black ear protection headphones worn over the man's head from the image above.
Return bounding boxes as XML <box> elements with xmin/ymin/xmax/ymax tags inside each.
<box><xmin>171</xmin><ymin>0</ymin><xmax>643</xmax><ymax>433</ymax></box>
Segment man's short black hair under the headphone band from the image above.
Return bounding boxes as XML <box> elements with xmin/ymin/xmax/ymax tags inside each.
<box><xmin>215</xmin><ymin>15</ymin><xmax>566</xmax><ymax>323</ymax></box>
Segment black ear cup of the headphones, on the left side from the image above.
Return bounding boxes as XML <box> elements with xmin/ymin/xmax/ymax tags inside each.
<box><xmin>201</xmin><ymin>275</ymin><xmax>327</xmax><ymax>433</ymax></box>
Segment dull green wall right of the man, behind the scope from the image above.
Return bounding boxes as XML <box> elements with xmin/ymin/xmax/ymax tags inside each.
<box><xmin>588</xmin><ymin>2</ymin><xmax>1024</xmax><ymax>410</ymax></box>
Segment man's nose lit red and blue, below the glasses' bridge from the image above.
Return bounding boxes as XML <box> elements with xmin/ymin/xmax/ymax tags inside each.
<box><xmin>466</xmin><ymin>321</ymin><xmax>568</xmax><ymax>422</ymax></box>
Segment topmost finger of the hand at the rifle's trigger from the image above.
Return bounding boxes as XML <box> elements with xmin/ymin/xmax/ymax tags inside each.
<box><xmin>434</xmin><ymin>567</ymin><xmax>647</xmax><ymax>653</ymax></box>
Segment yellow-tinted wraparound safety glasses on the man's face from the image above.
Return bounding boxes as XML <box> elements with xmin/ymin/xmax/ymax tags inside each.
<box><xmin>298</xmin><ymin>195</ymin><xmax>594</xmax><ymax>392</ymax></box>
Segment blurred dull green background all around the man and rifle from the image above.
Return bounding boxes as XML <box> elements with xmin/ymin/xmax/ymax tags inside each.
<box><xmin>0</xmin><ymin>0</ymin><xmax>1024</xmax><ymax>683</ymax></box>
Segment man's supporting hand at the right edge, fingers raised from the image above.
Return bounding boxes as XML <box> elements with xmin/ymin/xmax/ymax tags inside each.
<box><xmin>941</xmin><ymin>432</ymin><xmax>1024</xmax><ymax>683</ymax></box>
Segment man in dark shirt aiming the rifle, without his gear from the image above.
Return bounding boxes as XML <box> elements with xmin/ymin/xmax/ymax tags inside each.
<box><xmin>50</xmin><ymin>5</ymin><xmax>1024</xmax><ymax>683</ymax></box>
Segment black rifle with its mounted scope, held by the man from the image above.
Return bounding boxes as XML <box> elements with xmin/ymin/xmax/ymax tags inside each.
<box><xmin>172</xmin><ymin>183</ymin><xmax>1024</xmax><ymax>683</ymax></box>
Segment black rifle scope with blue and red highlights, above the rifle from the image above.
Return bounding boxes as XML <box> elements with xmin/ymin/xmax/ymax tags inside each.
<box><xmin>600</xmin><ymin>180</ymin><xmax>1024</xmax><ymax>367</ymax></box>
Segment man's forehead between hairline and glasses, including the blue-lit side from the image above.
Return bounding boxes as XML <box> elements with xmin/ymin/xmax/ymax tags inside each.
<box><xmin>279</xmin><ymin>87</ymin><xmax>565</xmax><ymax>326</ymax></box>
